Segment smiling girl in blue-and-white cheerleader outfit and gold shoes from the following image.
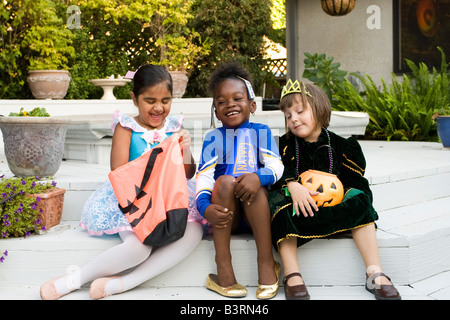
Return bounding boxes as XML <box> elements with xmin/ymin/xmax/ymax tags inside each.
<box><xmin>196</xmin><ymin>63</ymin><xmax>283</xmax><ymax>299</ymax></box>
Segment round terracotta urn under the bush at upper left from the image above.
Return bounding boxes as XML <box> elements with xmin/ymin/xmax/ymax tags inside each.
<box><xmin>27</xmin><ymin>70</ymin><xmax>70</xmax><ymax>99</ymax></box>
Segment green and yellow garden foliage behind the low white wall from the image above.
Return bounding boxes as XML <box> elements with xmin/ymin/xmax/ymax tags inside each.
<box><xmin>0</xmin><ymin>0</ymin><xmax>271</xmax><ymax>99</ymax></box>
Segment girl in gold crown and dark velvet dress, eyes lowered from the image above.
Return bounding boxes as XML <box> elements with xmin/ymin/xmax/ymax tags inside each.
<box><xmin>269</xmin><ymin>80</ymin><xmax>400</xmax><ymax>300</ymax></box>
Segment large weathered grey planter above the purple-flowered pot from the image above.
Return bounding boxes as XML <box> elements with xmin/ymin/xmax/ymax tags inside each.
<box><xmin>0</xmin><ymin>108</ymin><xmax>70</xmax><ymax>177</ymax></box>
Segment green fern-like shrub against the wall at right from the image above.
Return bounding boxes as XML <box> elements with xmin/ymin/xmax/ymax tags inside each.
<box><xmin>334</xmin><ymin>48</ymin><xmax>450</xmax><ymax>141</ymax></box>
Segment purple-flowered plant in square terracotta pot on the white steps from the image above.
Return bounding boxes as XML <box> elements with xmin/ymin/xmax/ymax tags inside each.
<box><xmin>0</xmin><ymin>175</ymin><xmax>66</xmax><ymax>239</ymax></box>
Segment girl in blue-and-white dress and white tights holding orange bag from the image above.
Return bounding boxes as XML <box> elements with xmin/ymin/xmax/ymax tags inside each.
<box><xmin>40</xmin><ymin>65</ymin><xmax>204</xmax><ymax>300</ymax></box>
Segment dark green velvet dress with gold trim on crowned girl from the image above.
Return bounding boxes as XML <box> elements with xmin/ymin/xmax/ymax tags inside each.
<box><xmin>269</xmin><ymin>129</ymin><xmax>378</xmax><ymax>251</ymax></box>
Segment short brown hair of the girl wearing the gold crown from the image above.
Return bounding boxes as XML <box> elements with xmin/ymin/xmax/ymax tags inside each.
<box><xmin>279</xmin><ymin>82</ymin><xmax>331</xmax><ymax>128</ymax></box>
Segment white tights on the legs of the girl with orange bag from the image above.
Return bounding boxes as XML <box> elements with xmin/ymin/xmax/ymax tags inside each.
<box><xmin>55</xmin><ymin>222</ymin><xmax>203</xmax><ymax>295</ymax></box>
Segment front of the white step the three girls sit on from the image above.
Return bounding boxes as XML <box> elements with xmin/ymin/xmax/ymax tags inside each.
<box><xmin>0</xmin><ymin>197</ymin><xmax>450</xmax><ymax>287</ymax></box>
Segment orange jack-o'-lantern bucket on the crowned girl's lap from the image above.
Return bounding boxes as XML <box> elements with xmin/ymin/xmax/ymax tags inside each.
<box><xmin>300</xmin><ymin>170</ymin><xmax>344</xmax><ymax>207</ymax></box>
